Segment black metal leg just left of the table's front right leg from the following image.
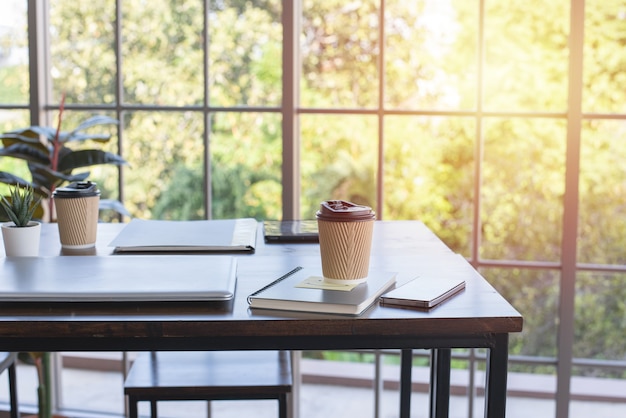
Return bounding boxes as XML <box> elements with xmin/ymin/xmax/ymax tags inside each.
<box><xmin>430</xmin><ymin>348</ymin><xmax>452</xmax><ymax>418</ymax></box>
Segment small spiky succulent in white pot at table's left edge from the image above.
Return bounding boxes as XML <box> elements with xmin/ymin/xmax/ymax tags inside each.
<box><xmin>0</xmin><ymin>185</ymin><xmax>41</xmax><ymax>256</ymax></box>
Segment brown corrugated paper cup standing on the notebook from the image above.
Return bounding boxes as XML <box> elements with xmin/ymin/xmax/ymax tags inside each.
<box><xmin>316</xmin><ymin>200</ymin><xmax>376</xmax><ymax>283</ymax></box>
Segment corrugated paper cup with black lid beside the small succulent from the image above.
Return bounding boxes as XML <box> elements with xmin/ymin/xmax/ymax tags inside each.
<box><xmin>53</xmin><ymin>182</ymin><xmax>100</xmax><ymax>249</ymax></box>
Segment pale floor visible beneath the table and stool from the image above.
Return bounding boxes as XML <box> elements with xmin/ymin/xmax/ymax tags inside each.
<box><xmin>0</xmin><ymin>366</ymin><xmax>626</xmax><ymax>418</ymax></box>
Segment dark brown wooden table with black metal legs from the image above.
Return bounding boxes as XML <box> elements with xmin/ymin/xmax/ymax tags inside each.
<box><xmin>0</xmin><ymin>221</ymin><xmax>523</xmax><ymax>418</ymax></box>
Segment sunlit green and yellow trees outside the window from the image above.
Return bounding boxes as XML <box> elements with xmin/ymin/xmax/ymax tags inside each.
<box><xmin>8</xmin><ymin>0</ymin><xmax>626</xmax><ymax>380</ymax></box>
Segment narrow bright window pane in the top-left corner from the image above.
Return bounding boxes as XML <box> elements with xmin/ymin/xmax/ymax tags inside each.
<box><xmin>0</xmin><ymin>0</ymin><xmax>30</xmax><ymax>104</ymax></box>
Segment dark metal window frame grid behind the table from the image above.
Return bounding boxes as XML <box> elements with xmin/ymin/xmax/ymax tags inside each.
<box><xmin>9</xmin><ymin>0</ymin><xmax>626</xmax><ymax>418</ymax></box>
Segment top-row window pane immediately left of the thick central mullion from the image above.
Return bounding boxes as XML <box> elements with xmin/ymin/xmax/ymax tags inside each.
<box><xmin>207</xmin><ymin>0</ymin><xmax>283</xmax><ymax>106</ymax></box>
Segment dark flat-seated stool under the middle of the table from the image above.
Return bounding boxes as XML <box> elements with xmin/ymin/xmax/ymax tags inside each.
<box><xmin>124</xmin><ymin>351</ymin><xmax>292</xmax><ymax>418</ymax></box>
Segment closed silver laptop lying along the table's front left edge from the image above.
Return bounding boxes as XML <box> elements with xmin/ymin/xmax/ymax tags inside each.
<box><xmin>0</xmin><ymin>255</ymin><xmax>237</xmax><ymax>302</ymax></box>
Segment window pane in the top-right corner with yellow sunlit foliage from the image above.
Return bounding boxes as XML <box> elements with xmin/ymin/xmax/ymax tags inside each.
<box><xmin>583</xmin><ymin>0</ymin><xmax>626</xmax><ymax>113</ymax></box>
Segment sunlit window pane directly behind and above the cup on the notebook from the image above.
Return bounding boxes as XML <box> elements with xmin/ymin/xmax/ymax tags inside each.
<box><xmin>300</xmin><ymin>115</ymin><xmax>378</xmax><ymax>219</ymax></box>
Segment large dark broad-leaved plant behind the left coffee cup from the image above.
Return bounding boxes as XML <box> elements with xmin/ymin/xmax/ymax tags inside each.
<box><xmin>0</xmin><ymin>96</ymin><xmax>128</xmax><ymax>220</ymax></box>
